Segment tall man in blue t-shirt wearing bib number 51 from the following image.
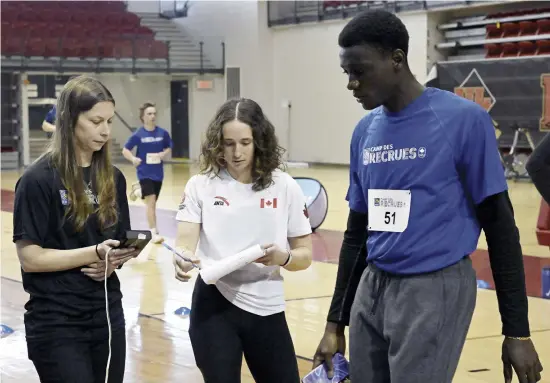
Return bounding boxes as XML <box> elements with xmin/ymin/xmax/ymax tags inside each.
<box><xmin>314</xmin><ymin>10</ymin><xmax>542</xmax><ymax>383</ymax></box>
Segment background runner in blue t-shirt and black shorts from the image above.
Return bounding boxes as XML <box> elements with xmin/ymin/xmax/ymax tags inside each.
<box><xmin>122</xmin><ymin>102</ymin><xmax>172</xmax><ymax>243</ymax></box>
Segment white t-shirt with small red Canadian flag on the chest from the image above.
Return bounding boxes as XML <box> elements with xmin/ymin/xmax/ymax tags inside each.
<box><xmin>176</xmin><ymin>170</ymin><xmax>311</xmax><ymax>316</ymax></box>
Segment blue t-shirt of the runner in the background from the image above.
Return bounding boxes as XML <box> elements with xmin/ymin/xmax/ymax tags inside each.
<box><xmin>124</xmin><ymin>126</ymin><xmax>172</xmax><ymax>181</ymax></box>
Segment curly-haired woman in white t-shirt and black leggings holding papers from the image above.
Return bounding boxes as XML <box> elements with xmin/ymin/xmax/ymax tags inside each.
<box><xmin>174</xmin><ymin>99</ymin><xmax>312</xmax><ymax>383</ymax></box>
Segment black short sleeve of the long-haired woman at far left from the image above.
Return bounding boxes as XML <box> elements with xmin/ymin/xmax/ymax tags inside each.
<box><xmin>13</xmin><ymin>168</ymin><xmax>53</xmax><ymax>247</ymax></box>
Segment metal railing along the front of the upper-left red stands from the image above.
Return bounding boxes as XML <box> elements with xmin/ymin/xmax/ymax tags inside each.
<box><xmin>2</xmin><ymin>33</ymin><xmax>225</xmax><ymax>74</ymax></box>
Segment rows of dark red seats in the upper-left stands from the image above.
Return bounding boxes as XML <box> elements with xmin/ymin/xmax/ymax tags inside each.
<box><xmin>1</xmin><ymin>1</ymin><xmax>168</xmax><ymax>59</ymax></box>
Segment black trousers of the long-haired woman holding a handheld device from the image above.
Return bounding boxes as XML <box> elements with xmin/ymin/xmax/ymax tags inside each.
<box><xmin>27</xmin><ymin>328</ymin><xmax>126</xmax><ymax>383</ymax></box>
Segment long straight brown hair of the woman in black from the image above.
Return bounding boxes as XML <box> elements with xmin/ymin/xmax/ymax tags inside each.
<box><xmin>45</xmin><ymin>76</ymin><xmax>117</xmax><ymax>231</ymax></box>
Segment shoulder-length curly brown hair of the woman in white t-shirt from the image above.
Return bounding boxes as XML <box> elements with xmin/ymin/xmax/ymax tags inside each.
<box><xmin>200</xmin><ymin>98</ymin><xmax>285</xmax><ymax>191</ymax></box>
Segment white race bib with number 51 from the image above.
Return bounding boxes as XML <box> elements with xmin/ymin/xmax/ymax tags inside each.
<box><xmin>368</xmin><ymin>189</ymin><xmax>411</xmax><ymax>233</ymax></box>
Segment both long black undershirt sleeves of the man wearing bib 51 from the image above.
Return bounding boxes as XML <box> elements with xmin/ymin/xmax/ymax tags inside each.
<box><xmin>327</xmin><ymin>191</ymin><xmax>532</xmax><ymax>337</ymax></box>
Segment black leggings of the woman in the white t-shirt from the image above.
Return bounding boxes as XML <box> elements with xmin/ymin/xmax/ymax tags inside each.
<box><xmin>189</xmin><ymin>277</ymin><xmax>300</xmax><ymax>383</ymax></box>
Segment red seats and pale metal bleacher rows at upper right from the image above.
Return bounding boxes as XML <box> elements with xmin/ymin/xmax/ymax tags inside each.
<box><xmin>437</xmin><ymin>8</ymin><xmax>550</xmax><ymax>59</ymax></box>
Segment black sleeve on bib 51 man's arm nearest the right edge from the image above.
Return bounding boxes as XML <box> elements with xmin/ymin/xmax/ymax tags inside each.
<box><xmin>477</xmin><ymin>191</ymin><xmax>529</xmax><ymax>337</ymax></box>
